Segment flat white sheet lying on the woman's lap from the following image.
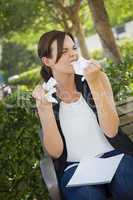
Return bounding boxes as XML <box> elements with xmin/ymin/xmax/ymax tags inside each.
<box><xmin>66</xmin><ymin>153</ymin><xmax>124</xmax><ymax>187</ymax></box>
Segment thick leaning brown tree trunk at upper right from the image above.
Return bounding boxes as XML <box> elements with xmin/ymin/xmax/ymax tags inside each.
<box><xmin>88</xmin><ymin>0</ymin><xmax>121</xmax><ymax>63</ymax></box>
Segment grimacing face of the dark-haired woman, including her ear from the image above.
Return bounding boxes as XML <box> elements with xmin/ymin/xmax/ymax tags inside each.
<box><xmin>51</xmin><ymin>35</ymin><xmax>78</xmax><ymax>74</ymax></box>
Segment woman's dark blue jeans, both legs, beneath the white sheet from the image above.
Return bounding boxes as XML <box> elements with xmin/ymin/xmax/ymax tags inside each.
<box><xmin>60</xmin><ymin>151</ymin><xmax>133</xmax><ymax>200</ymax></box>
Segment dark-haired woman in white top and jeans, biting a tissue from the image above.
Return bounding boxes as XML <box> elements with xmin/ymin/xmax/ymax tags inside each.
<box><xmin>33</xmin><ymin>30</ymin><xmax>133</xmax><ymax>200</ymax></box>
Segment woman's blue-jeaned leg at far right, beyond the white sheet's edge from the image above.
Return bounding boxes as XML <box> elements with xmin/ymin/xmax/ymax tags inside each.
<box><xmin>108</xmin><ymin>154</ymin><xmax>133</xmax><ymax>200</ymax></box>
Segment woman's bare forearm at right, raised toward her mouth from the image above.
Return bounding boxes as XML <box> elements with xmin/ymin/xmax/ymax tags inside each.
<box><xmin>87</xmin><ymin>77</ymin><xmax>120</xmax><ymax>137</ymax></box>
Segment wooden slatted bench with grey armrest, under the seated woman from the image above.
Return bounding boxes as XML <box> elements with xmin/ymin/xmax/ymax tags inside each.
<box><xmin>39</xmin><ymin>97</ymin><xmax>133</xmax><ymax>200</ymax></box>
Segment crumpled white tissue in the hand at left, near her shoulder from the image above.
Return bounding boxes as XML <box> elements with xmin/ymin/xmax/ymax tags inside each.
<box><xmin>42</xmin><ymin>77</ymin><xmax>58</xmax><ymax>103</ymax></box>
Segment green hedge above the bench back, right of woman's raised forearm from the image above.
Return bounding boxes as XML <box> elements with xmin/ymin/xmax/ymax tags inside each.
<box><xmin>105</xmin><ymin>55</ymin><xmax>133</xmax><ymax>101</ymax></box>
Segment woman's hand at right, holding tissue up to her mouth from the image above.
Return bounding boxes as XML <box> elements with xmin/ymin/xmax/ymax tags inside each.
<box><xmin>84</xmin><ymin>59</ymin><xmax>102</xmax><ymax>83</ymax></box>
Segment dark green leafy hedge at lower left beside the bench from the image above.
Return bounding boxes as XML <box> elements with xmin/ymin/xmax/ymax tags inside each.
<box><xmin>0</xmin><ymin>92</ymin><xmax>49</xmax><ymax>200</ymax></box>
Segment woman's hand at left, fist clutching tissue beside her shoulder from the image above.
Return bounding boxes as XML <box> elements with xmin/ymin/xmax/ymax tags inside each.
<box><xmin>32</xmin><ymin>85</ymin><xmax>52</xmax><ymax>109</ymax></box>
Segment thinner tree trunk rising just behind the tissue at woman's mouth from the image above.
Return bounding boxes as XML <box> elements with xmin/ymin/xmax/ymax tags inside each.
<box><xmin>71</xmin><ymin>13</ymin><xmax>89</xmax><ymax>59</ymax></box>
